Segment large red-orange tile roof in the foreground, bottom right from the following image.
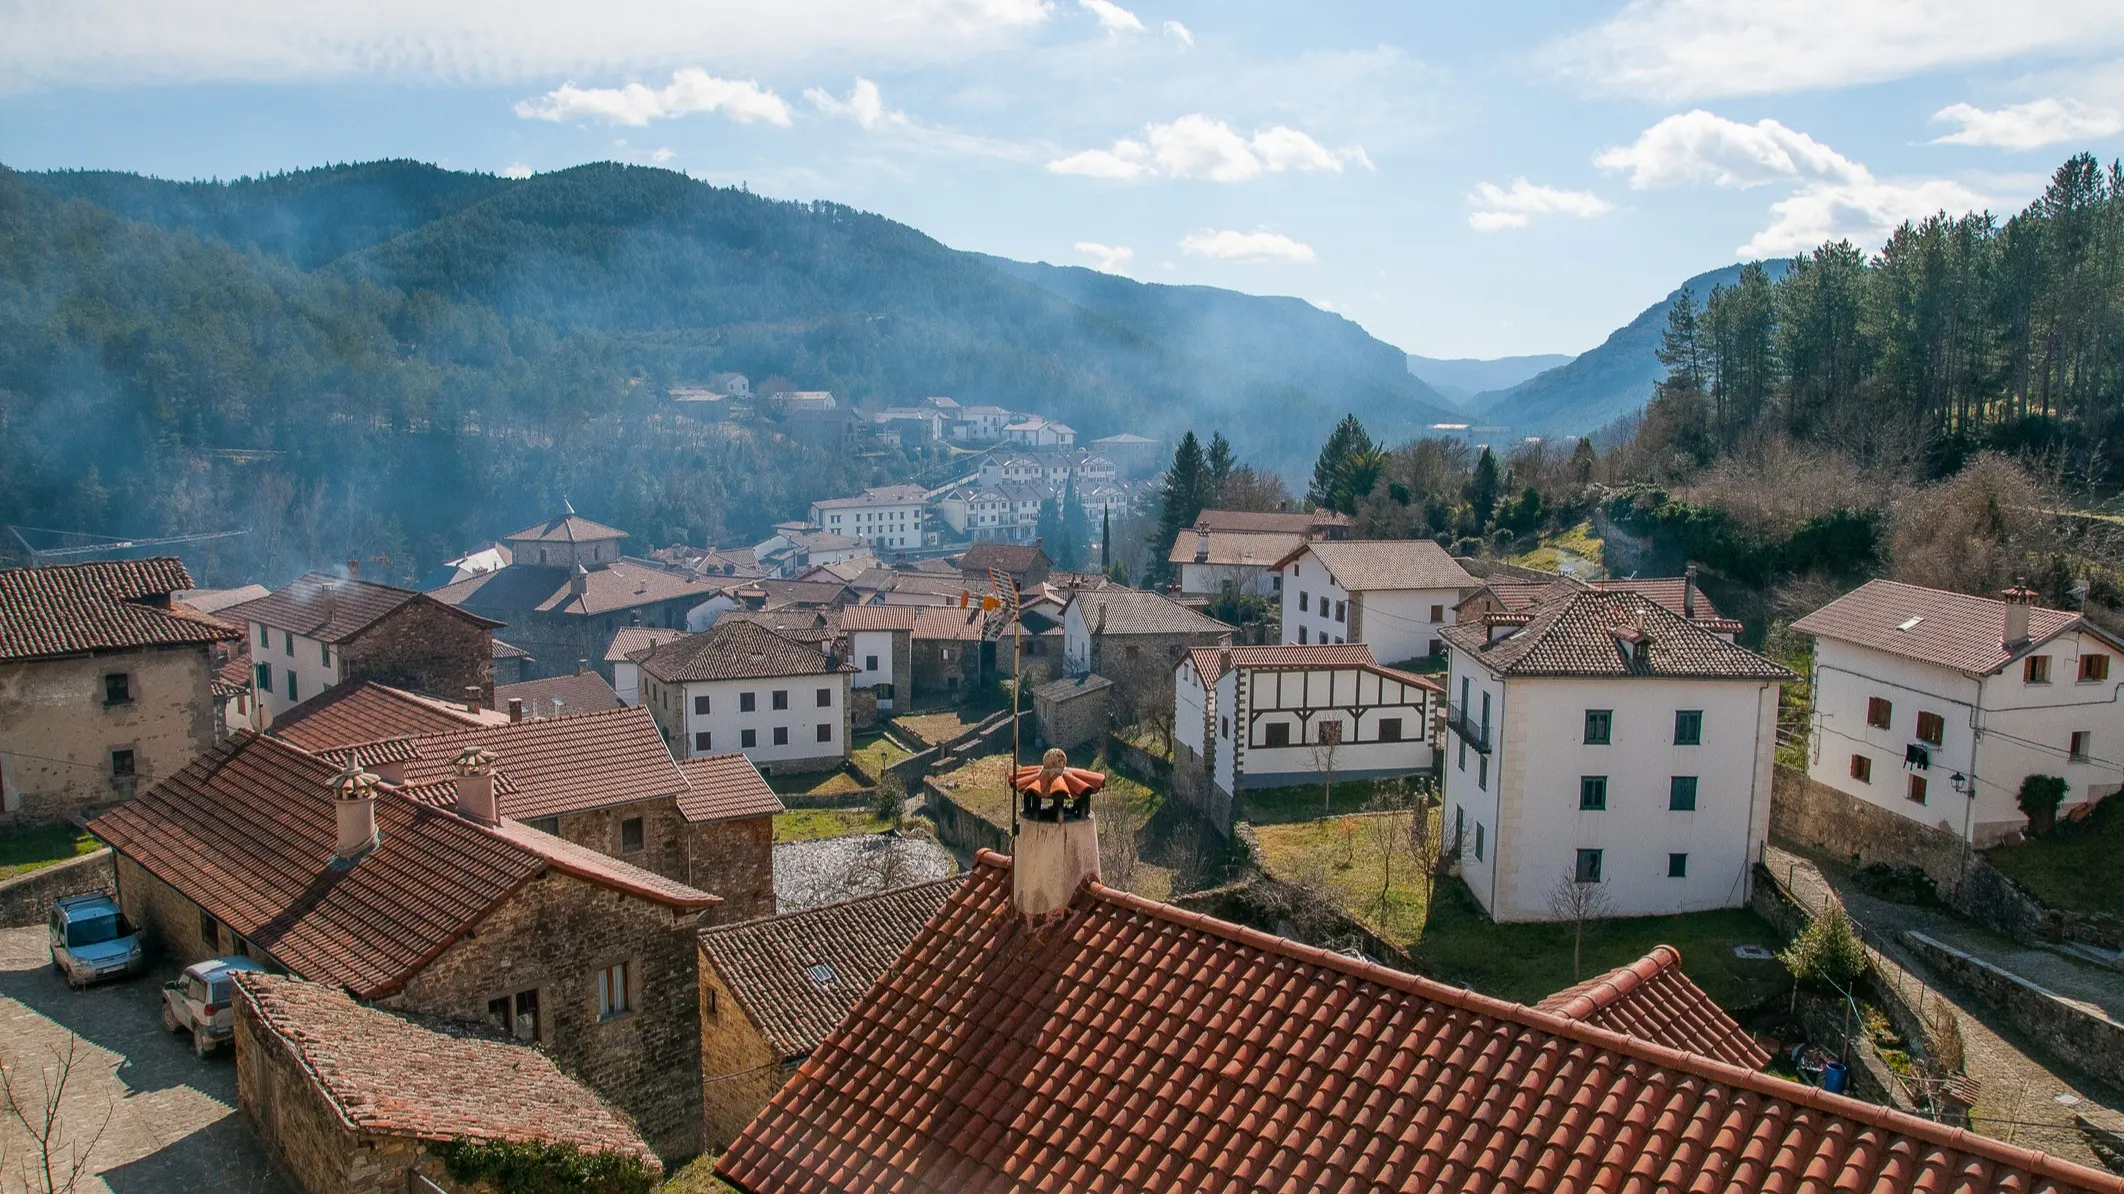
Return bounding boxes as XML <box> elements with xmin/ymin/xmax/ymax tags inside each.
<box><xmin>718</xmin><ymin>852</ymin><xmax>2124</xmax><ymax>1194</ymax></box>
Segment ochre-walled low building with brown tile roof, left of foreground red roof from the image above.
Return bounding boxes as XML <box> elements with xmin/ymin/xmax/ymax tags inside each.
<box><xmin>701</xmin><ymin>875</ymin><xmax>964</xmax><ymax>1152</ymax></box>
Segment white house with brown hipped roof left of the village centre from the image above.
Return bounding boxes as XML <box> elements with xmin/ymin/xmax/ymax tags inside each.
<box><xmin>637</xmin><ymin>618</ymin><xmax>854</xmax><ymax>773</ymax></box>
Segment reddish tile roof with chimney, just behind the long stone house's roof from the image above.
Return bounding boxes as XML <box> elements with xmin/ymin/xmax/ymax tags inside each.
<box><xmin>406</xmin><ymin>705</ymin><xmax>686</xmax><ymax>820</ymax></box>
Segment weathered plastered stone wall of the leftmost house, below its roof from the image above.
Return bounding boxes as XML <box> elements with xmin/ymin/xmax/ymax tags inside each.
<box><xmin>0</xmin><ymin>646</ymin><xmax>215</xmax><ymax>833</ymax></box>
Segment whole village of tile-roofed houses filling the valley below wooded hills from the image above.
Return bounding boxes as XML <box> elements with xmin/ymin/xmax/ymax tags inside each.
<box><xmin>12</xmin><ymin>444</ymin><xmax>2124</xmax><ymax>1194</ymax></box>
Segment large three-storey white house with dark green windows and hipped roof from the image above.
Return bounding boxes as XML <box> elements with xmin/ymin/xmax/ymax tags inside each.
<box><xmin>1442</xmin><ymin>580</ymin><xmax>1795</xmax><ymax>922</ymax></box>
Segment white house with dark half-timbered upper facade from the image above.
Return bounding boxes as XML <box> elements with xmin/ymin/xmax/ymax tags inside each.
<box><xmin>1172</xmin><ymin>644</ymin><xmax>1444</xmax><ymax>807</ymax></box>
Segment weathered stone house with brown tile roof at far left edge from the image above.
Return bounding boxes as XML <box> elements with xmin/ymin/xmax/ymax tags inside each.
<box><xmin>0</xmin><ymin>559</ymin><xmax>242</xmax><ymax>833</ymax></box>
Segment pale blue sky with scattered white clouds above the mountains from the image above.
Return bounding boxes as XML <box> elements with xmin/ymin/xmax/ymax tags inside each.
<box><xmin>0</xmin><ymin>0</ymin><xmax>2124</xmax><ymax>357</ymax></box>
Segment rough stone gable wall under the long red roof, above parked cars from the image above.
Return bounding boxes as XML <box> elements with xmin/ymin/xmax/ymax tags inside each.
<box><xmin>389</xmin><ymin>871</ymin><xmax>701</xmax><ymax>1166</ymax></box>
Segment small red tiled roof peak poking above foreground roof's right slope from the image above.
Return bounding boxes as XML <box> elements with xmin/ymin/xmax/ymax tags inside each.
<box><xmin>1534</xmin><ymin>945</ymin><xmax>1769</xmax><ymax>1069</ymax></box>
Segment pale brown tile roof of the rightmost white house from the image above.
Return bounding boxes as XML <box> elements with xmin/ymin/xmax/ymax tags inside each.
<box><xmin>1793</xmin><ymin>580</ymin><xmax>2092</xmax><ymax>676</ymax></box>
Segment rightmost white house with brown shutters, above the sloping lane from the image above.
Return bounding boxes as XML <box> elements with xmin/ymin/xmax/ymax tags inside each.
<box><xmin>1793</xmin><ymin>580</ymin><xmax>2124</xmax><ymax>848</ymax></box>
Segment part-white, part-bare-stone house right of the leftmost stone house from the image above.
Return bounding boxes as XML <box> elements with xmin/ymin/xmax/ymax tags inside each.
<box><xmin>221</xmin><ymin>572</ymin><xmax>501</xmax><ymax>729</ymax></box>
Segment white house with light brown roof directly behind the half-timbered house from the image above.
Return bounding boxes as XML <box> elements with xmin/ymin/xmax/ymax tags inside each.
<box><xmin>1277</xmin><ymin>540</ymin><xmax>1478</xmax><ymax>663</ymax></box>
